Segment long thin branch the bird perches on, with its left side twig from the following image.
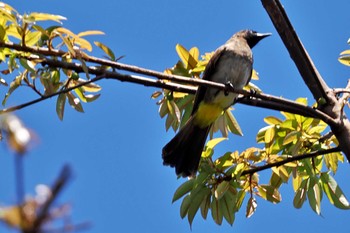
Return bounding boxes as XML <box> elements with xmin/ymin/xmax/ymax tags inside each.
<box><xmin>0</xmin><ymin>42</ymin><xmax>332</xmax><ymax>124</ymax></box>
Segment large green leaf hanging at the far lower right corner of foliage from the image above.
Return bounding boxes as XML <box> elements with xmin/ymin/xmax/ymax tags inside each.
<box><xmin>321</xmin><ymin>173</ymin><xmax>350</xmax><ymax>209</ymax></box>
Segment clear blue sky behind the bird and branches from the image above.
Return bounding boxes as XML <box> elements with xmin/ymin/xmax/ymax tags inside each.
<box><xmin>0</xmin><ymin>0</ymin><xmax>350</xmax><ymax>233</ymax></box>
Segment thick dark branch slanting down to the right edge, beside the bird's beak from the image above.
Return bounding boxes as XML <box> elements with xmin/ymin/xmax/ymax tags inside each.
<box><xmin>261</xmin><ymin>0</ymin><xmax>350</xmax><ymax>161</ymax></box>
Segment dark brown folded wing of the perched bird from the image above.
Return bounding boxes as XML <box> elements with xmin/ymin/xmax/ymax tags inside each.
<box><xmin>192</xmin><ymin>46</ymin><xmax>226</xmax><ymax>114</ymax></box>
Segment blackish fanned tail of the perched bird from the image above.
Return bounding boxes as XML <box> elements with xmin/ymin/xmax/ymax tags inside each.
<box><xmin>162</xmin><ymin>117</ymin><xmax>210</xmax><ymax>177</ymax></box>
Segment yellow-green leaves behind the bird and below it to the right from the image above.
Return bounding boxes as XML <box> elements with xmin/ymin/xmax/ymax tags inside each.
<box><xmin>160</xmin><ymin>45</ymin><xmax>350</xmax><ymax>225</ymax></box>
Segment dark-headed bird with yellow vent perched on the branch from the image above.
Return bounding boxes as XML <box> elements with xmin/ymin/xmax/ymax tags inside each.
<box><xmin>162</xmin><ymin>30</ymin><xmax>271</xmax><ymax>177</ymax></box>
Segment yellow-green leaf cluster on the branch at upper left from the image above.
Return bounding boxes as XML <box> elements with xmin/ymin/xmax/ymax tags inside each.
<box><xmin>0</xmin><ymin>3</ymin><xmax>116</xmax><ymax>120</ymax></box>
